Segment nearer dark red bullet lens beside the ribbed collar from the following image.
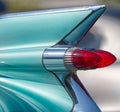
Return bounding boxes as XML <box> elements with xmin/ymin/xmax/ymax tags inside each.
<box><xmin>72</xmin><ymin>49</ymin><xmax>102</xmax><ymax>69</ymax></box>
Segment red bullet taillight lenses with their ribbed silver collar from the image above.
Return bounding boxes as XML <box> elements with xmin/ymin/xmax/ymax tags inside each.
<box><xmin>65</xmin><ymin>48</ymin><xmax>116</xmax><ymax>70</ymax></box>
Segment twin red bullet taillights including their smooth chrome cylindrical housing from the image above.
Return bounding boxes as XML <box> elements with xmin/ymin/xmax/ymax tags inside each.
<box><xmin>43</xmin><ymin>46</ymin><xmax>116</xmax><ymax>73</ymax></box>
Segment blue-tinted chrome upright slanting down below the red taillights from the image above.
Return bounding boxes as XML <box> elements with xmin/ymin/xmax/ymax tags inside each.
<box><xmin>66</xmin><ymin>74</ymin><xmax>101</xmax><ymax>112</ymax></box>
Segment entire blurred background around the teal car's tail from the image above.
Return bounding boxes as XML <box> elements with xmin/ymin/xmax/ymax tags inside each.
<box><xmin>0</xmin><ymin>0</ymin><xmax>120</xmax><ymax>112</ymax></box>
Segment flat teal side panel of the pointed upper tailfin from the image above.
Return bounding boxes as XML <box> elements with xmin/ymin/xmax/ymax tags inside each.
<box><xmin>0</xmin><ymin>10</ymin><xmax>91</xmax><ymax>48</ymax></box>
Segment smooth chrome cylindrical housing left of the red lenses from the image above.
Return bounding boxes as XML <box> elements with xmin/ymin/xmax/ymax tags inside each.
<box><xmin>43</xmin><ymin>46</ymin><xmax>69</xmax><ymax>73</ymax></box>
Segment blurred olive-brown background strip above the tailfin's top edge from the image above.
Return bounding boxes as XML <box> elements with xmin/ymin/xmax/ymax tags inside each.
<box><xmin>4</xmin><ymin>0</ymin><xmax>120</xmax><ymax>12</ymax></box>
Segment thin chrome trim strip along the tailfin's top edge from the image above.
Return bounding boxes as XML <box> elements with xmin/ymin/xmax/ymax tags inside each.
<box><xmin>0</xmin><ymin>5</ymin><xmax>105</xmax><ymax>19</ymax></box>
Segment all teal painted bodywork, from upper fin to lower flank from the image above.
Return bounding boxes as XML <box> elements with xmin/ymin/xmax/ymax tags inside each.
<box><xmin>0</xmin><ymin>5</ymin><xmax>105</xmax><ymax>112</ymax></box>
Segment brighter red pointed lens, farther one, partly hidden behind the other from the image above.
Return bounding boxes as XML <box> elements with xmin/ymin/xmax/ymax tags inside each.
<box><xmin>95</xmin><ymin>50</ymin><xmax>116</xmax><ymax>68</ymax></box>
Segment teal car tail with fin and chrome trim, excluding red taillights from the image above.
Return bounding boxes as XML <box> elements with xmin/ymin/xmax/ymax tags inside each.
<box><xmin>0</xmin><ymin>6</ymin><xmax>105</xmax><ymax>112</ymax></box>
